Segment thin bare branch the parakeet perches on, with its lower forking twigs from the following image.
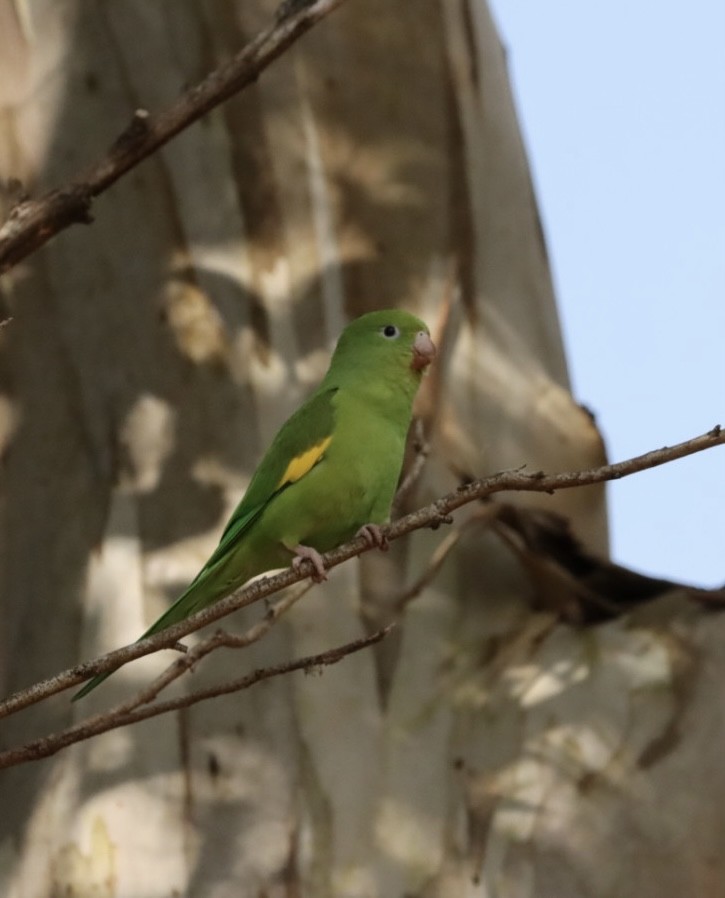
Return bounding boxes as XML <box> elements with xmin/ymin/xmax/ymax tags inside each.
<box><xmin>0</xmin><ymin>425</ymin><xmax>725</xmax><ymax>767</ymax></box>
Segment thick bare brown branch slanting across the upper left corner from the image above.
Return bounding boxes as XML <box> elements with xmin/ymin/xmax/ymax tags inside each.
<box><xmin>0</xmin><ymin>0</ymin><xmax>343</xmax><ymax>274</ymax></box>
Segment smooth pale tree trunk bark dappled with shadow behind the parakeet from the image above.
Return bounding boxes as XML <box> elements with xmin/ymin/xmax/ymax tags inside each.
<box><xmin>0</xmin><ymin>0</ymin><xmax>725</xmax><ymax>898</ymax></box>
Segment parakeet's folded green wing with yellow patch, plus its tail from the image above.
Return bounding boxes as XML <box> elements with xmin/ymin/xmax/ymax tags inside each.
<box><xmin>73</xmin><ymin>387</ymin><xmax>337</xmax><ymax>701</ymax></box>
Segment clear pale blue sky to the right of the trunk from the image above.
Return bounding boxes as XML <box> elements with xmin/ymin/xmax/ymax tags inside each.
<box><xmin>491</xmin><ymin>0</ymin><xmax>725</xmax><ymax>586</ymax></box>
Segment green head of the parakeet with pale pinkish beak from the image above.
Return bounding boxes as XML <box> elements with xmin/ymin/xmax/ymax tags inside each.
<box><xmin>330</xmin><ymin>309</ymin><xmax>436</xmax><ymax>384</ymax></box>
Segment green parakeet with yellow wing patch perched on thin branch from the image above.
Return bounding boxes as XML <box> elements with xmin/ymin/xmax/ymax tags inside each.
<box><xmin>74</xmin><ymin>310</ymin><xmax>436</xmax><ymax>700</ymax></box>
